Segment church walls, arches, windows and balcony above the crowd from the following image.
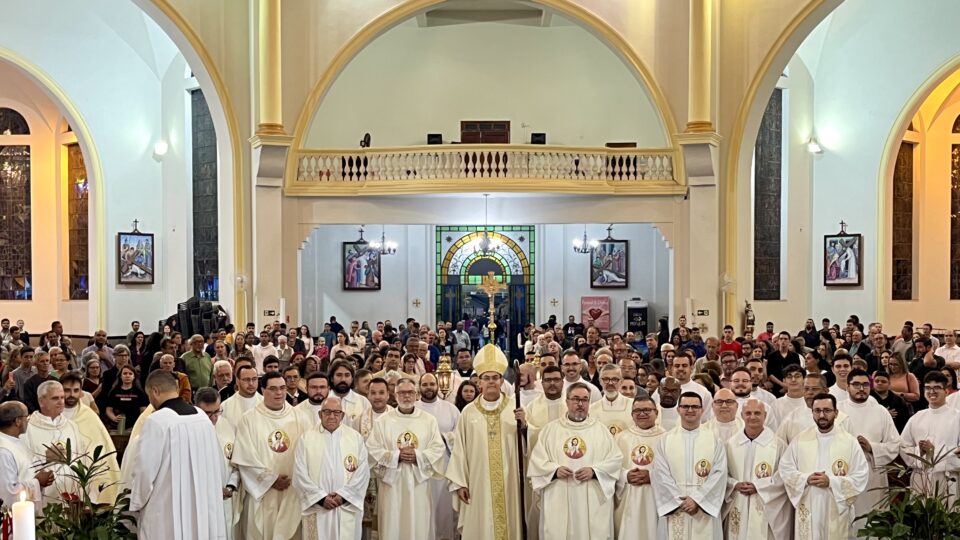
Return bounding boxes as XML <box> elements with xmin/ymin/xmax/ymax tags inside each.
<box><xmin>0</xmin><ymin>0</ymin><xmax>960</xmax><ymax>536</ymax></box>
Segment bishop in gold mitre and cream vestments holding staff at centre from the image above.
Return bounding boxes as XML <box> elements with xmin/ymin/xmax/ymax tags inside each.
<box><xmin>447</xmin><ymin>344</ymin><xmax>526</xmax><ymax>540</ymax></box>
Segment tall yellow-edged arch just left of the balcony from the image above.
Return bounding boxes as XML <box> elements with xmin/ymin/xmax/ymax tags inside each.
<box><xmin>133</xmin><ymin>0</ymin><xmax>249</xmax><ymax>320</ymax></box>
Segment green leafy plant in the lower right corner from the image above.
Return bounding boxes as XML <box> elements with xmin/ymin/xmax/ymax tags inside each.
<box><xmin>858</xmin><ymin>449</ymin><xmax>960</xmax><ymax>540</ymax></box>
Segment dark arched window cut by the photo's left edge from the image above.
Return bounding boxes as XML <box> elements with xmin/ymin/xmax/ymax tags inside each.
<box><xmin>0</xmin><ymin>108</ymin><xmax>33</xmax><ymax>300</ymax></box>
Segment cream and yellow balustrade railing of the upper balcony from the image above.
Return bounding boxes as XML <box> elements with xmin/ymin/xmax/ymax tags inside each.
<box><xmin>288</xmin><ymin>144</ymin><xmax>681</xmax><ymax>195</ymax></box>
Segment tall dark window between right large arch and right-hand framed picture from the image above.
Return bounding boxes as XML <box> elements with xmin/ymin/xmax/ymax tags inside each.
<box><xmin>753</xmin><ymin>88</ymin><xmax>783</xmax><ymax>300</ymax></box>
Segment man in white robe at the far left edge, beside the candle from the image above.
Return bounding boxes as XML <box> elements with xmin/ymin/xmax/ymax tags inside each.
<box><xmin>0</xmin><ymin>401</ymin><xmax>53</xmax><ymax>511</ymax></box>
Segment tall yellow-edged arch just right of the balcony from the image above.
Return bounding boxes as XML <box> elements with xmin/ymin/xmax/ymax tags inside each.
<box><xmin>721</xmin><ymin>0</ymin><xmax>843</xmax><ymax>321</ymax></box>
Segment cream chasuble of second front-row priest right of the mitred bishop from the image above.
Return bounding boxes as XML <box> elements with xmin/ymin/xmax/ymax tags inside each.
<box><xmin>614</xmin><ymin>425</ymin><xmax>665</xmax><ymax>540</ymax></box>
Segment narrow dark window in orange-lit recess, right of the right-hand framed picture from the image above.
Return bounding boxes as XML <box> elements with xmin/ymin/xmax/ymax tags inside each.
<box><xmin>890</xmin><ymin>141</ymin><xmax>916</xmax><ymax>300</ymax></box>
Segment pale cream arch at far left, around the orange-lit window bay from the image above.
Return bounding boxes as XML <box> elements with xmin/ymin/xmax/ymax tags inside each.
<box><xmin>0</xmin><ymin>47</ymin><xmax>108</xmax><ymax>328</ymax></box>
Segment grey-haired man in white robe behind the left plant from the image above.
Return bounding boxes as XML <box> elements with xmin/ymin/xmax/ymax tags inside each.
<box><xmin>23</xmin><ymin>381</ymin><xmax>92</xmax><ymax>506</ymax></box>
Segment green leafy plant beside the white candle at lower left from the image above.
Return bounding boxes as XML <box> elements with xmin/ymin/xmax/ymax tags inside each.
<box><xmin>37</xmin><ymin>439</ymin><xmax>137</xmax><ymax>540</ymax></box>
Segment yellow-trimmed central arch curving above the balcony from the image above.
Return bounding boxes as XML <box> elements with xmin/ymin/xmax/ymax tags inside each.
<box><xmin>285</xmin><ymin>0</ymin><xmax>678</xmax><ymax>183</ymax></box>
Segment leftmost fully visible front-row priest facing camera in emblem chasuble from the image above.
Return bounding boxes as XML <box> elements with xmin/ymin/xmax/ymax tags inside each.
<box><xmin>227</xmin><ymin>370</ymin><xmax>313</xmax><ymax>540</ymax></box>
